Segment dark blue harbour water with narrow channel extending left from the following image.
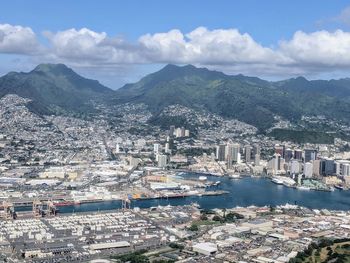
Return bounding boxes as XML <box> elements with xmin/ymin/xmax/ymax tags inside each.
<box><xmin>18</xmin><ymin>173</ymin><xmax>350</xmax><ymax>213</ymax></box>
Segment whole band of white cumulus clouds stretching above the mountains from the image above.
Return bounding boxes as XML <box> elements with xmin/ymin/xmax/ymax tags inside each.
<box><xmin>0</xmin><ymin>24</ymin><xmax>350</xmax><ymax>76</ymax></box>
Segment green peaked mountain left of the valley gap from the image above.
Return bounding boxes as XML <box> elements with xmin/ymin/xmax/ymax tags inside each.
<box><xmin>0</xmin><ymin>64</ymin><xmax>114</xmax><ymax>114</ymax></box>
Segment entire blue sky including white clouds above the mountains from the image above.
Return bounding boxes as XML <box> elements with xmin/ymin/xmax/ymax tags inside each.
<box><xmin>0</xmin><ymin>0</ymin><xmax>350</xmax><ymax>89</ymax></box>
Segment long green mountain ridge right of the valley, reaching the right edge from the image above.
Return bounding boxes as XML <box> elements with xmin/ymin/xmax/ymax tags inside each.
<box><xmin>116</xmin><ymin>65</ymin><xmax>350</xmax><ymax>130</ymax></box>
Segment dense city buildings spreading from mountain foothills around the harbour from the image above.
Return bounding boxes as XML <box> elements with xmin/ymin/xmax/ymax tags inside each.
<box><xmin>0</xmin><ymin>95</ymin><xmax>350</xmax><ymax>262</ymax></box>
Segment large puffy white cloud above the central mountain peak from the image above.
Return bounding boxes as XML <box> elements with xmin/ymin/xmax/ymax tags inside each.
<box><xmin>139</xmin><ymin>27</ymin><xmax>286</xmax><ymax>65</ymax></box>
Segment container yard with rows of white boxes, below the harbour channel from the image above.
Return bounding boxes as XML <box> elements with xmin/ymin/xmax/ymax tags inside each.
<box><xmin>0</xmin><ymin>206</ymin><xmax>197</xmax><ymax>262</ymax></box>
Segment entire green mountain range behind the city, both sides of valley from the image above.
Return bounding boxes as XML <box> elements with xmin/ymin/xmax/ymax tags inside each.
<box><xmin>0</xmin><ymin>64</ymin><xmax>350</xmax><ymax>131</ymax></box>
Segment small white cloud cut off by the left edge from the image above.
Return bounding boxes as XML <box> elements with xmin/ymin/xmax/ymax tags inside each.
<box><xmin>0</xmin><ymin>24</ymin><xmax>40</xmax><ymax>55</ymax></box>
